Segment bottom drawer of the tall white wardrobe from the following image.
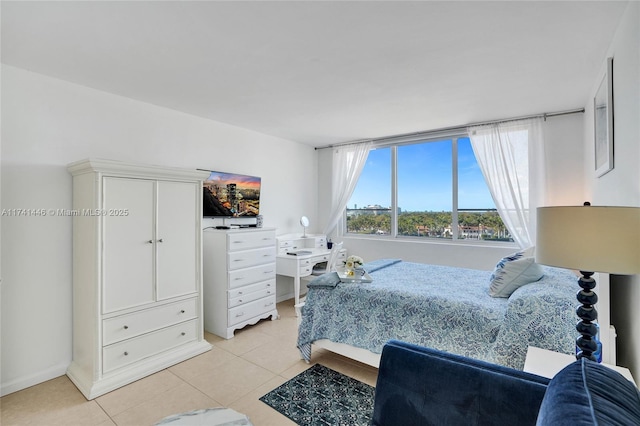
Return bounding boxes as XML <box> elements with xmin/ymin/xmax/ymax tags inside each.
<box><xmin>102</xmin><ymin>320</ymin><xmax>197</xmax><ymax>373</ymax></box>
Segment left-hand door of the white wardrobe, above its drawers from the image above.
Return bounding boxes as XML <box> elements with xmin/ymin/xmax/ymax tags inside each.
<box><xmin>104</xmin><ymin>177</ymin><xmax>155</xmax><ymax>313</ymax></box>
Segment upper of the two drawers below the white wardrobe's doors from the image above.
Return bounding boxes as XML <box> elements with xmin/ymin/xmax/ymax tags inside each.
<box><xmin>102</xmin><ymin>298</ymin><xmax>198</xmax><ymax>346</ymax></box>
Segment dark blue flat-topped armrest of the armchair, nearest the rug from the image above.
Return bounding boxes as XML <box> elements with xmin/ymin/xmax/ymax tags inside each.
<box><xmin>372</xmin><ymin>340</ymin><xmax>549</xmax><ymax>426</ymax></box>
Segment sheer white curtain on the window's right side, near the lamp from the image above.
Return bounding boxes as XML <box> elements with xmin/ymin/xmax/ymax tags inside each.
<box><xmin>468</xmin><ymin>118</ymin><xmax>547</xmax><ymax>248</ymax></box>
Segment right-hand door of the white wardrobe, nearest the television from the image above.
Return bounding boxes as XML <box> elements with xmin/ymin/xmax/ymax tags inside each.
<box><xmin>156</xmin><ymin>181</ymin><xmax>202</xmax><ymax>300</ymax></box>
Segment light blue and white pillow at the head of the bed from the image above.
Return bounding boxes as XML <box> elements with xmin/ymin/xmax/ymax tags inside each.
<box><xmin>489</xmin><ymin>247</ymin><xmax>544</xmax><ymax>297</ymax></box>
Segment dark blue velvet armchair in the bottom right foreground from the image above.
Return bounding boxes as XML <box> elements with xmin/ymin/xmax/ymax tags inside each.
<box><xmin>372</xmin><ymin>340</ymin><xmax>640</xmax><ymax>426</ymax></box>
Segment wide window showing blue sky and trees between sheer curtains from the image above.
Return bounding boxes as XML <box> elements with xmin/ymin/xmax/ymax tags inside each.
<box><xmin>346</xmin><ymin>135</ymin><xmax>513</xmax><ymax>241</ymax></box>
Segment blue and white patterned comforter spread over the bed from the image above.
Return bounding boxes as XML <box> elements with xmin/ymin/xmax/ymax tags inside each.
<box><xmin>298</xmin><ymin>260</ymin><xmax>578</xmax><ymax>369</ymax></box>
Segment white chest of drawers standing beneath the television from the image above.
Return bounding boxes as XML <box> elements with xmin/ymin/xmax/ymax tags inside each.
<box><xmin>203</xmin><ymin>228</ymin><xmax>278</xmax><ymax>339</ymax></box>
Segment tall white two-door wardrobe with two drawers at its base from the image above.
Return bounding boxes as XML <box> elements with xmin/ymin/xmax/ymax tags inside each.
<box><xmin>67</xmin><ymin>159</ymin><xmax>211</xmax><ymax>399</ymax></box>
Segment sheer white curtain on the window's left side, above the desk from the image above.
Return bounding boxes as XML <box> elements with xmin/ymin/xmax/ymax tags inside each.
<box><xmin>324</xmin><ymin>142</ymin><xmax>372</xmax><ymax>235</ymax></box>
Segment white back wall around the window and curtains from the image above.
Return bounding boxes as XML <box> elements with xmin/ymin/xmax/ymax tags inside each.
<box><xmin>318</xmin><ymin>114</ymin><xmax>584</xmax><ymax>269</ymax></box>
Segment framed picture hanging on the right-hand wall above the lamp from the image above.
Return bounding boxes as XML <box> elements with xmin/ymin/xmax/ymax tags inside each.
<box><xmin>593</xmin><ymin>58</ymin><xmax>613</xmax><ymax>177</ymax></box>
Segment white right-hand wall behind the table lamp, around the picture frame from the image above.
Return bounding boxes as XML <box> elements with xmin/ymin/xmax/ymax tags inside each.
<box><xmin>584</xmin><ymin>2</ymin><xmax>640</xmax><ymax>381</ymax></box>
